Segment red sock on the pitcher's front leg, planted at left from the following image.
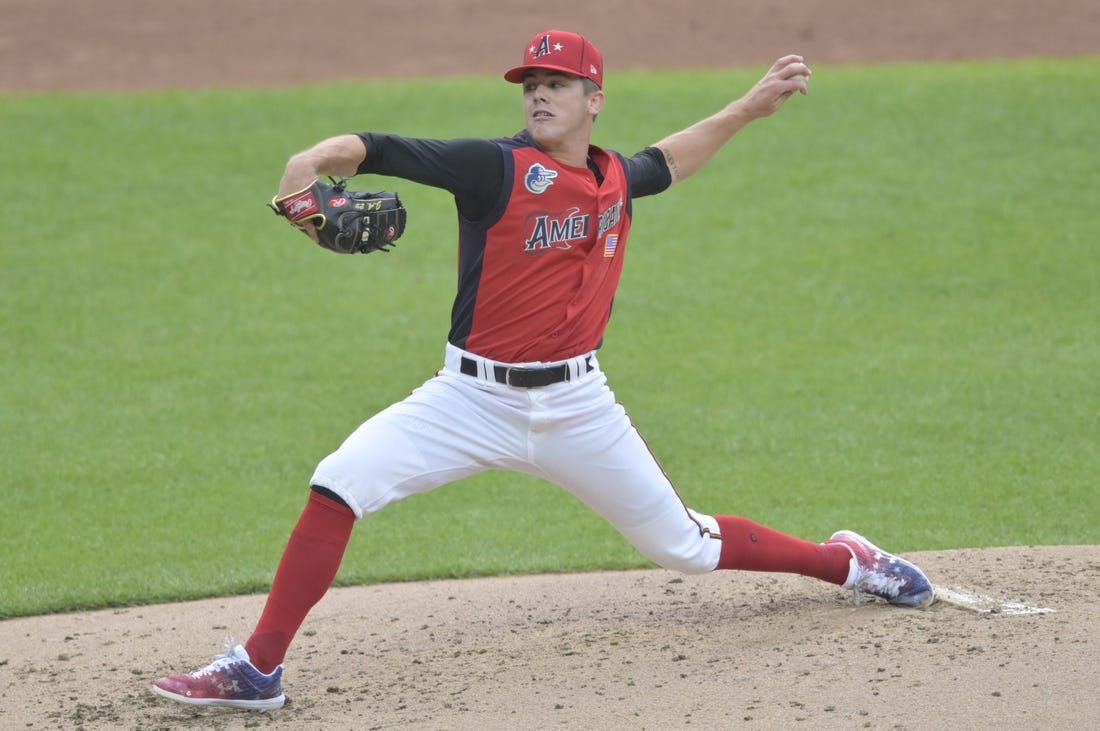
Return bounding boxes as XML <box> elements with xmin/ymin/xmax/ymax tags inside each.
<box><xmin>244</xmin><ymin>491</ymin><xmax>355</xmax><ymax>674</ymax></box>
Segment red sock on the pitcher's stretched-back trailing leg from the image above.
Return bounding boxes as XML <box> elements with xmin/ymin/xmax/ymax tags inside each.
<box><xmin>714</xmin><ymin>516</ymin><xmax>851</xmax><ymax>585</ymax></box>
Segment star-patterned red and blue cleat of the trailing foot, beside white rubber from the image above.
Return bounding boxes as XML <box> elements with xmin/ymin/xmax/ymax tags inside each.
<box><xmin>825</xmin><ymin>531</ymin><xmax>936</xmax><ymax>608</ymax></box>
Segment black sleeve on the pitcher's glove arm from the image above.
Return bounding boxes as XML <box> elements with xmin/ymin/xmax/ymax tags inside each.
<box><xmin>358</xmin><ymin>132</ymin><xmax>504</xmax><ymax>220</ymax></box>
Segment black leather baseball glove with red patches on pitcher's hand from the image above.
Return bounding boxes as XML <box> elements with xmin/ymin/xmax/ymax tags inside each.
<box><xmin>268</xmin><ymin>178</ymin><xmax>407</xmax><ymax>254</ymax></box>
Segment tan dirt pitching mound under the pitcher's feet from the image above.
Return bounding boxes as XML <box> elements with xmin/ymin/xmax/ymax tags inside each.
<box><xmin>0</xmin><ymin>546</ymin><xmax>1100</xmax><ymax>731</ymax></box>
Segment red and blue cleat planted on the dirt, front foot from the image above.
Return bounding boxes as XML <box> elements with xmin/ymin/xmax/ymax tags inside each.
<box><xmin>153</xmin><ymin>638</ymin><xmax>286</xmax><ymax>711</ymax></box>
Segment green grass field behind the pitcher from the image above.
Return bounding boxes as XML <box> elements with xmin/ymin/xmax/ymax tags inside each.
<box><xmin>0</xmin><ymin>58</ymin><xmax>1100</xmax><ymax>617</ymax></box>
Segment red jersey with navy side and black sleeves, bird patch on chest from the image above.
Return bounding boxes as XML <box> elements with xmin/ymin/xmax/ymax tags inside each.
<box><xmin>360</xmin><ymin>132</ymin><xmax>671</xmax><ymax>363</ymax></box>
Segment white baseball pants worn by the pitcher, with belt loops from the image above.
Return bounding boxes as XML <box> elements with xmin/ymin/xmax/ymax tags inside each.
<box><xmin>311</xmin><ymin>344</ymin><xmax>722</xmax><ymax>574</ymax></box>
